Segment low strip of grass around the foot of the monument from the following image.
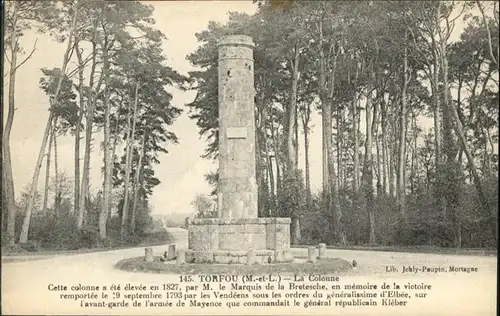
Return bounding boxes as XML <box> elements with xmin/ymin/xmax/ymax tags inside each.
<box><xmin>115</xmin><ymin>257</ymin><xmax>352</xmax><ymax>275</ymax></box>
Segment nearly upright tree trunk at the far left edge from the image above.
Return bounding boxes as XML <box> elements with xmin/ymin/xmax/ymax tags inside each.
<box><xmin>2</xmin><ymin>1</ymin><xmax>19</xmax><ymax>244</ymax></box>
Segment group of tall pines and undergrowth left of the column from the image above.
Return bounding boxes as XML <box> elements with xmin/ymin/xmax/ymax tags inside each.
<box><xmin>2</xmin><ymin>0</ymin><xmax>185</xmax><ymax>250</ymax></box>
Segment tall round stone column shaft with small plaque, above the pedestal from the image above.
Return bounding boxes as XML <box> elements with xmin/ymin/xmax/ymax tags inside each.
<box><xmin>217</xmin><ymin>35</ymin><xmax>258</xmax><ymax>218</ymax></box>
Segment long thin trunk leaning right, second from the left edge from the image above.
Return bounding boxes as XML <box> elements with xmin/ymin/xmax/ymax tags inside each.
<box><xmin>19</xmin><ymin>2</ymin><xmax>78</xmax><ymax>243</ymax></box>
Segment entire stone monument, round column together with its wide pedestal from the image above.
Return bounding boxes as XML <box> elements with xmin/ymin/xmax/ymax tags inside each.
<box><xmin>186</xmin><ymin>35</ymin><xmax>291</xmax><ymax>263</ymax></box>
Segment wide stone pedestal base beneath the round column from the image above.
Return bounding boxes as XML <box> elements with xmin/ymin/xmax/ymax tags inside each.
<box><xmin>186</xmin><ymin>218</ymin><xmax>292</xmax><ymax>264</ymax></box>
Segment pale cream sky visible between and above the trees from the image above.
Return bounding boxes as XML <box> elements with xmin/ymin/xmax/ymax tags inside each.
<box><xmin>4</xmin><ymin>1</ymin><xmax>482</xmax><ymax>215</ymax></box>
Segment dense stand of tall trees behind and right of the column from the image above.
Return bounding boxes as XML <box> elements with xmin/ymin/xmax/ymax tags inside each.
<box><xmin>187</xmin><ymin>1</ymin><xmax>499</xmax><ymax>248</ymax></box>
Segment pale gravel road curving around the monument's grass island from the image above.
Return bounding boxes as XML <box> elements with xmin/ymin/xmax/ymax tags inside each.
<box><xmin>2</xmin><ymin>229</ymin><xmax>497</xmax><ymax>316</ymax></box>
